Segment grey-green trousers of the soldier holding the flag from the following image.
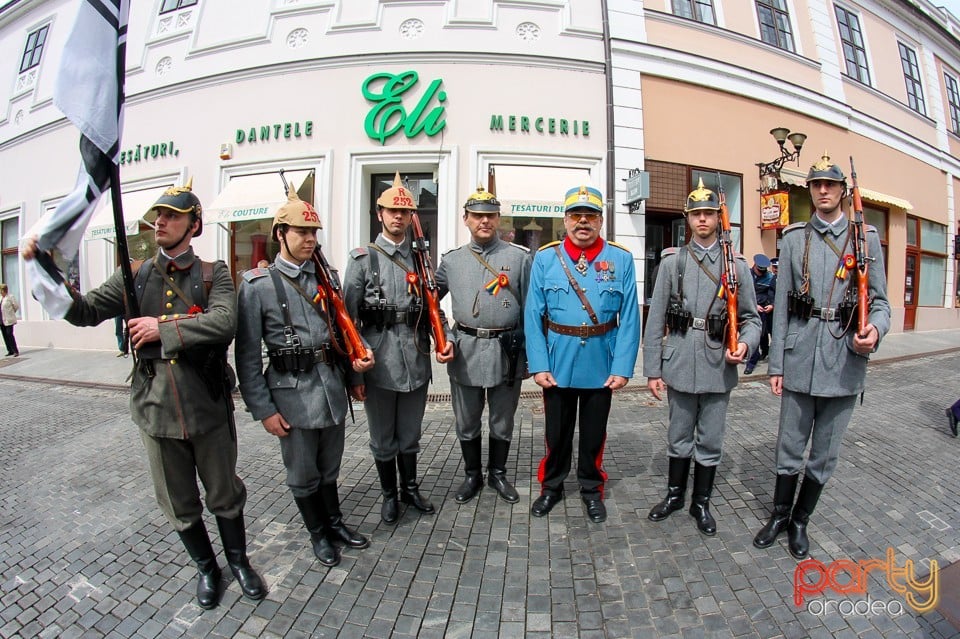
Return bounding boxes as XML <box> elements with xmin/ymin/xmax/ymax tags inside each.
<box><xmin>140</xmin><ymin>425</ymin><xmax>247</xmax><ymax>530</ymax></box>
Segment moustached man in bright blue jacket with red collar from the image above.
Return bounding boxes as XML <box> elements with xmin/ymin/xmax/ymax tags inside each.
<box><xmin>524</xmin><ymin>186</ymin><xmax>640</xmax><ymax>523</ymax></box>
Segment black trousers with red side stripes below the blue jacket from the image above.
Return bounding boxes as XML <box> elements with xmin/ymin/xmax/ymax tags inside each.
<box><xmin>537</xmin><ymin>387</ymin><xmax>613</xmax><ymax>499</ymax></box>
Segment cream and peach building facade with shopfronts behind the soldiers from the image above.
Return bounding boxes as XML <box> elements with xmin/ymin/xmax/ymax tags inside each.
<box><xmin>0</xmin><ymin>0</ymin><xmax>960</xmax><ymax>348</ymax></box>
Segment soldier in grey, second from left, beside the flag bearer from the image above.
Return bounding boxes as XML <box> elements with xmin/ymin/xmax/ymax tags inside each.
<box><xmin>236</xmin><ymin>188</ymin><xmax>373</xmax><ymax>566</ymax></box>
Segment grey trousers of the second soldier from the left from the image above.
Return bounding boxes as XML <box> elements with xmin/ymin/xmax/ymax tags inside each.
<box><xmin>278</xmin><ymin>424</ymin><xmax>345</xmax><ymax>497</ymax></box>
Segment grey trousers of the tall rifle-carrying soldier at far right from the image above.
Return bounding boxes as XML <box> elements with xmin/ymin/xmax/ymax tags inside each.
<box><xmin>777</xmin><ymin>389</ymin><xmax>857</xmax><ymax>484</ymax></box>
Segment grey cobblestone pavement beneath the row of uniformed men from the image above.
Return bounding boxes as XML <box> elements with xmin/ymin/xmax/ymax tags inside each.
<box><xmin>0</xmin><ymin>354</ymin><xmax>960</xmax><ymax>638</ymax></box>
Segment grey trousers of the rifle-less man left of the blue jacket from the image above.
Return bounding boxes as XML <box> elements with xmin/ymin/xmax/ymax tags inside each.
<box><xmin>450</xmin><ymin>379</ymin><xmax>521</xmax><ymax>442</ymax></box>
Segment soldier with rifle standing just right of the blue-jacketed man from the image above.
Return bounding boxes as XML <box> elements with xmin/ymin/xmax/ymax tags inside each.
<box><xmin>643</xmin><ymin>180</ymin><xmax>760</xmax><ymax>536</ymax></box>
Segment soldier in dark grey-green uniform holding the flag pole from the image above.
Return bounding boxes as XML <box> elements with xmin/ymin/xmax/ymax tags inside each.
<box><xmin>23</xmin><ymin>179</ymin><xmax>266</xmax><ymax>609</ymax></box>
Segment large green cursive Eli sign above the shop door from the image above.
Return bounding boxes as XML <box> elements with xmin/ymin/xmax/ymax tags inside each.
<box><xmin>362</xmin><ymin>71</ymin><xmax>447</xmax><ymax>145</ymax></box>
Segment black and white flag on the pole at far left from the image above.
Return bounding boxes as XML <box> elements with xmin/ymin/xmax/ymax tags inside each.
<box><xmin>26</xmin><ymin>0</ymin><xmax>130</xmax><ymax>318</ymax></box>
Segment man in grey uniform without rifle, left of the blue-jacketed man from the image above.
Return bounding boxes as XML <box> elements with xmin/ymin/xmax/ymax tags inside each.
<box><xmin>437</xmin><ymin>187</ymin><xmax>533</xmax><ymax>504</ymax></box>
